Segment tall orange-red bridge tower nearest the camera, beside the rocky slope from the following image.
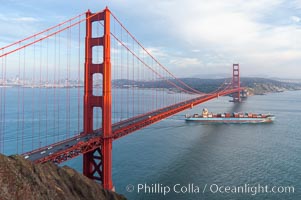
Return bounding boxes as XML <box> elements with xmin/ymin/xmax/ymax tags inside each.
<box><xmin>83</xmin><ymin>8</ymin><xmax>113</xmax><ymax>190</ymax></box>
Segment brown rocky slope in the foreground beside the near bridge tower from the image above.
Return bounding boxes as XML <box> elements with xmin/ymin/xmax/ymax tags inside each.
<box><xmin>0</xmin><ymin>154</ymin><xmax>126</xmax><ymax>200</ymax></box>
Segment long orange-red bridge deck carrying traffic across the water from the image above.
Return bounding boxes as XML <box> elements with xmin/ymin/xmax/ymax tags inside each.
<box><xmin>22</xmin><ymin>88</ymin><xmax>243</xmax><ymax>163</ymax></box>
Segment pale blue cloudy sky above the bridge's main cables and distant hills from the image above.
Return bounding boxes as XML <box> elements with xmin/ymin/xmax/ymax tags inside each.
<box><xmin>0</xmin><ymin>0</ymin><xmax>301</xmax><ymax>79</ymax></box>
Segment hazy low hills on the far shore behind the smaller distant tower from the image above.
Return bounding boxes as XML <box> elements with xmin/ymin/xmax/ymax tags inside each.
<box><xmin>113</xmin><ymin>77</ymin><xmax>301</xmax><ymax>95</ymax></box>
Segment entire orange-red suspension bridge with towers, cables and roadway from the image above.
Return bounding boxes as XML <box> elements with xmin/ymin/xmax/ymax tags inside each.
<box><xmin>0</xmin><ymin>8</ymin><xmax>243</xmax><ymax>190</ymax></box>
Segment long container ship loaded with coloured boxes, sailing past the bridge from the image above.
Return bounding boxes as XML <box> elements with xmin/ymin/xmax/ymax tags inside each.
<box><xmin>185</xmin><ymin>108</ymin><xmax>275</xmax><ymax>123</ymax></box>
